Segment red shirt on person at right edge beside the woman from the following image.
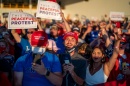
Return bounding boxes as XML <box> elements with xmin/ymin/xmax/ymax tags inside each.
<box><xmin>108</xmin><ymin>53</ymin><xmax>130</xmax><ymax>81</ymax></box>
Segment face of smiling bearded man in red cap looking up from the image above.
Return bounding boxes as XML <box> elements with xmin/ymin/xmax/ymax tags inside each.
<box><xmin>64</xmin><ymin>36</ymin><xmax>77</xmax><ymax>48</ymax></box>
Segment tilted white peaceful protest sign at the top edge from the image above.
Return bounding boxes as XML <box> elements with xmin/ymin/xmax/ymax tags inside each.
<box><xmin>36</xmin><ymin>0</ymin><xmax>62</xmax><ymax>20</ymax></box>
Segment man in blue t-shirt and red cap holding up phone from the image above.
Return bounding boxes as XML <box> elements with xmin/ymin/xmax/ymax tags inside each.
<box><xmin>14</xmin><ymin>31</ymin><xmax>62</xmax><ymax>86</ymax></box>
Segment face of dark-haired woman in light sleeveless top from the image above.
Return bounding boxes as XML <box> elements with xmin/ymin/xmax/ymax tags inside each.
<box><xmin>92</xmin><ymin>48</ymin><xmax>104</xmax><ymax>62</ymax></box>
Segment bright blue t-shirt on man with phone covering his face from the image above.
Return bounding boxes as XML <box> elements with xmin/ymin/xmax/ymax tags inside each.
<box><xmin>14</xmin><ymin>52</ymin><xmax>62</xmax><ymax>86</ymax></box>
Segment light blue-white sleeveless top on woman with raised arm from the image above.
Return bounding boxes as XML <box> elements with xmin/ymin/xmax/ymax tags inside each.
<box><xmin>85</xmin><ymin>66</ymin><xmax>108</xmax><ymax>86</ymax></box>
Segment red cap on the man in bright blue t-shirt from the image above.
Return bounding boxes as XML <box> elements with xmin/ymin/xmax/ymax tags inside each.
<box><xmin>31</xmin><ymin>31</ymin><xmax>48</xmax><ymax>47</ymax></box>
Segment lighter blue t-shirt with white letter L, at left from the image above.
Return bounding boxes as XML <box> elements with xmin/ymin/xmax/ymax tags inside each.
<box><xmin>18</xmin><ymin>38</ymin><xmax>31</xmax><ymax>55</ymax></box>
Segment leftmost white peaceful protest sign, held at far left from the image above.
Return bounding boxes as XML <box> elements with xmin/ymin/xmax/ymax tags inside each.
<box><xmin>8</xmin><ymin>12</ymin><xmax>37</xmax><ymax>29</ymax></box>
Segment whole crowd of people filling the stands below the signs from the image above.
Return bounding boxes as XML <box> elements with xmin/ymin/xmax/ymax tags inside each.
<box><xmin>0</xmin><ymin>8</ymin><xmax>130</xmax><ymax>86</ymax></box>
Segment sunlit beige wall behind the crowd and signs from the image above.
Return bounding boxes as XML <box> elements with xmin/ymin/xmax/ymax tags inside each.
<box><xmin>0</xmin><ymin>0</ymin><xmax>130</xmax><ymax>19</ymax></box>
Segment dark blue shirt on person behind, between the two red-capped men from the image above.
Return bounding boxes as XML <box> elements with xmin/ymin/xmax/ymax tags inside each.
<box><xmin>48</xmin><ymin>35</ymin><xmax>65</xmax><ymax>54</ymax></box>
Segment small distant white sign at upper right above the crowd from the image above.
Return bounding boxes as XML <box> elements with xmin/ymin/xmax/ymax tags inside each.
<box><xmin>110</xmin><ymin>12</ymin><xmax>125</xmax><ymax>21</ymax></box>
